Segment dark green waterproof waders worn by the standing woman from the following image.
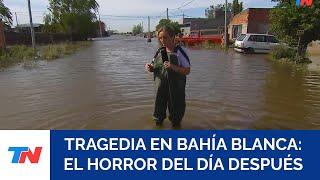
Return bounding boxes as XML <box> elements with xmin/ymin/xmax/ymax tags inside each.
<box><xmin>153</xmin><ymin>47</ymin><xmax>186</xmax><ymax>125</ymax></box>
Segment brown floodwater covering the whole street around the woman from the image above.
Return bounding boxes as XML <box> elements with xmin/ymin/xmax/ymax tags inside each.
<box><xmin>0</xmin><ymin>36</ymin><xmax>320</xmax><ymax>129</ymax></box>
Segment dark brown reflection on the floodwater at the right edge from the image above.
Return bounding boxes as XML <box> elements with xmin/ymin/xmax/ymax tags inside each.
<box><xmin>254</xmin><ymin>64</ymin><xmax>320</xmax><ymax>129</ymax></box>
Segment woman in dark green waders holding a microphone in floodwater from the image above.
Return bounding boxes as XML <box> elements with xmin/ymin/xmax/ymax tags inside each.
<box><xmin>145</xmin><ymin>26</ymin><xmax>190</xmax><ymax>128</ymax></box>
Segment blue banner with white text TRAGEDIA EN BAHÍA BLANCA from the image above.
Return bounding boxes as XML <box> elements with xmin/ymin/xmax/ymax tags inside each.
<box><xmin>50</xmin><ymin>131</ymin><xmax>320</xmax><ymax>180</ymax></box>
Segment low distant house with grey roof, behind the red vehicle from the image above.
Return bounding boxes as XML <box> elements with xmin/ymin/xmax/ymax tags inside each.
<box><xmin>180</xmin><ymin>10</ymin><xmax>231</xmax><ymax>36</ymax></box>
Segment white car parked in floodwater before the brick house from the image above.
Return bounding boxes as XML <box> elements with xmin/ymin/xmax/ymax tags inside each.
<box><xmin>234</xmin><ymin>34</ymin><xmax>280</xmax><ymax>53</ymax></box>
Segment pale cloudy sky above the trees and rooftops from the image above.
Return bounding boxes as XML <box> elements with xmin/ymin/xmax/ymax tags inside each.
<box><xmin>4</xmin><ymin>0</ymin><xmax>275</xmax><ymax>32</ymax></box>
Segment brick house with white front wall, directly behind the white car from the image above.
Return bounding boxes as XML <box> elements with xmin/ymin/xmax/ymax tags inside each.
<box><xmin>228</xmin><ymin>8</ymin><xmax>271</xmax><ymax>39</ymax></box>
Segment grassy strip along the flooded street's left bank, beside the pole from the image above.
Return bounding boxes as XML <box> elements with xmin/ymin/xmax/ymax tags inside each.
<box><xmin>0</xmin><ymin>41</ymin><xmax>92</xmax><ymax>68</ymax></box>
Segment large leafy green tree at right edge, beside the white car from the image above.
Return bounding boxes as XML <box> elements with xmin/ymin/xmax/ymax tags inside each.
<box><xmin>270</xmin><ymin>0</ymin><xmax>320</xmax><ymax>56</ymax></box>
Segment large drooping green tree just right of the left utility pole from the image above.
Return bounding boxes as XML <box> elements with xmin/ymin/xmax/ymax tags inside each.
<box><xmin>44</xmin><ymin>0</ymin><xmax>99</xmax><ymax>38</ymax></box>
